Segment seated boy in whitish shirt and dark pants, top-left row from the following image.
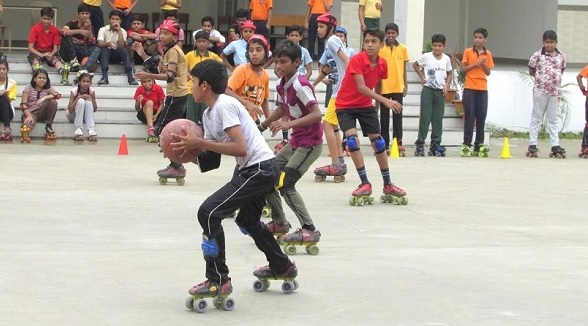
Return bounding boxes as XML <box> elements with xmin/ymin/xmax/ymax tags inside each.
<box><xmin>98</xmin><ymin>10</ymin><xmax>139</xmax><ymax>85</ymax></box>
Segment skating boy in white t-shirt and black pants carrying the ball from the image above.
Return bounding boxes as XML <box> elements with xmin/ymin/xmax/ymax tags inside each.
<box><xmin>172</xmin><ymin>60</ymin><xmax>298</xmax><ymax>308</ymax></box>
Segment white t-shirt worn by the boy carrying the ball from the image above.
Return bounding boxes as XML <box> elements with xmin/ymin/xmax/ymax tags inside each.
<box><xmin>202</xmin><ymin>94</ymin><xmax>275</xmax><ymax>169</ymax></box>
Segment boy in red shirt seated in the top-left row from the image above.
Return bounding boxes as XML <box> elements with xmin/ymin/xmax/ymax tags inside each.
<box><xmin>27</xmin><ymin>7</ymin><xmax>63</xmax><ymax>74</ymax></box>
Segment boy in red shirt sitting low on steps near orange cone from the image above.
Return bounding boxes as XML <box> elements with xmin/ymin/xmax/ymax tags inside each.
<box><xmin>133</xmin><ymin>77</ymin><xmax>165</xmax><ymax>143</ymax></box>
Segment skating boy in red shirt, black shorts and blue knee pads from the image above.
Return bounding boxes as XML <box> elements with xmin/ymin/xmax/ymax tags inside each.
<box><xmin>335</xmin><ymin>29</ymin><xmax>407</xmax><ymax>206</ymax></box>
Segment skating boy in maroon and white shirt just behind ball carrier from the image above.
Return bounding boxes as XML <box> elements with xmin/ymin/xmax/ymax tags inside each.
<box><xmin>259</xmin><ymin>40</ymin><xmax>323</xmax><ymax>250</ymax></box>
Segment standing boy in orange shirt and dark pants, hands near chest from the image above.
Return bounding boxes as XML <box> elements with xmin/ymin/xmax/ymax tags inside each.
<box><xmin>461</xmin><ymin>28</ymin><xmax>494</xmax><ymax>157</ymax></box>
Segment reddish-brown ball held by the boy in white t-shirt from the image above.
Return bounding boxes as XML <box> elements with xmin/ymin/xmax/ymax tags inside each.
<box><xmin>159</xmin><ymin>119</ymin><xmax>202</xmax><ymax>163</ymax></box>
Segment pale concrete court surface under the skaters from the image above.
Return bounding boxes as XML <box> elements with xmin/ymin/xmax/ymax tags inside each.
<box><xmin>0</xmin><ymin>139</ymin><xmax>588</xmax><ymax>326</ymax></box>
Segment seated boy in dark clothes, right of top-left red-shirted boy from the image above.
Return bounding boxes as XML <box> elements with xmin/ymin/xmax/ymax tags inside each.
<box><xmin>59</xmin><ymin>3</ymin><xmax>100</xmax><ymax>78</ymax></box>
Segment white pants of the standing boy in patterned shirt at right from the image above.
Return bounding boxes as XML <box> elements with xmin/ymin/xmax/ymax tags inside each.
<box><xmin>529</xmin><ymin>94</ymin><xmax>559</xmax><ymax>146</ymax></box>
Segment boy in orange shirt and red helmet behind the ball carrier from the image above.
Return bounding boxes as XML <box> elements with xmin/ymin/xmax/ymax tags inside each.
<box><xmin>226</xmin><ymin>34</ymin><xmax>269</xmax><ymax>124</ymax></box>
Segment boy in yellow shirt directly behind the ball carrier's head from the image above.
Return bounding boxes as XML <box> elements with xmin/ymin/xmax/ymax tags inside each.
<box><xmin>186</xmin><ymin>30</ymin><xmax>223</xmax><ymax>126</ymax></box>
